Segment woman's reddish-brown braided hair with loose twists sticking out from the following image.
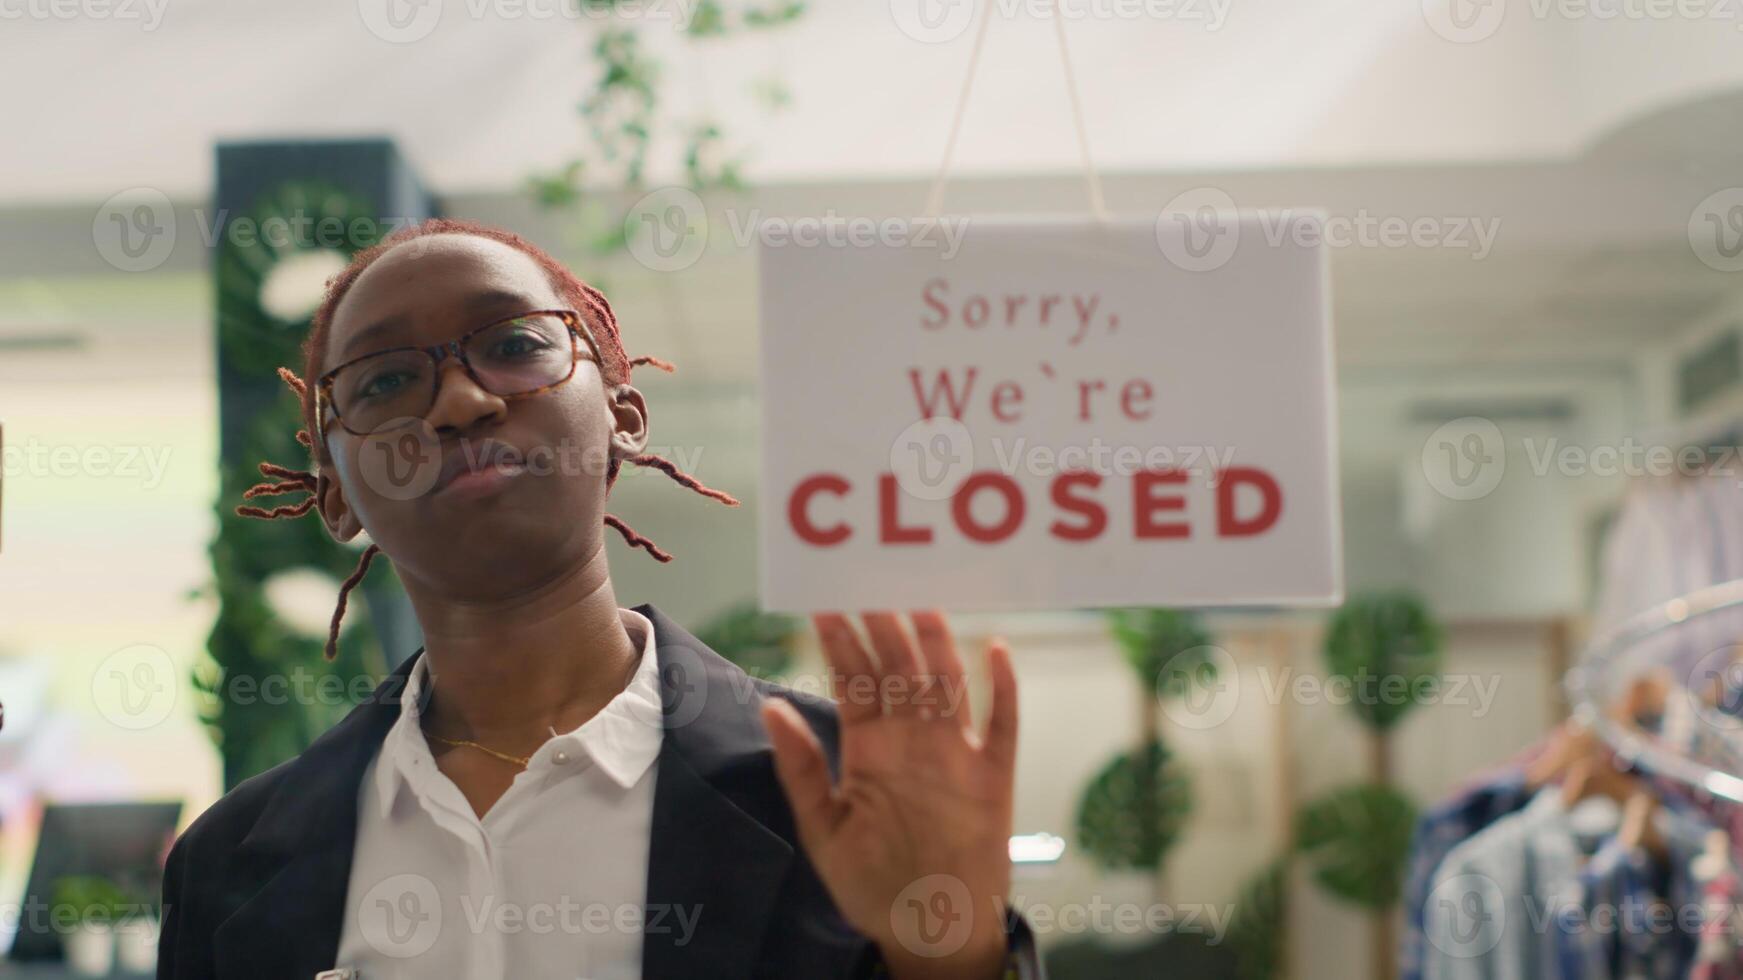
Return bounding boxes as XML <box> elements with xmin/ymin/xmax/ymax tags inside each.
<box><xmin>235</xmin><ymin>218</ymin><xmax>739</xmax><ymax>661</ymax></box>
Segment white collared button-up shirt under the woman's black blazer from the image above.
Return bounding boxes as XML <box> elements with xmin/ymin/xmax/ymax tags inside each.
<box><xmin>336</xmin><ymin>609</ymin><xmax>662</xmax><ymax>980</ymax></box>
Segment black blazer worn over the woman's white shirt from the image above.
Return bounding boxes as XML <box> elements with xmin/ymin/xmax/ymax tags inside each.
<box><xmin>157</xmin><ymin>603</ymin><xmax>1042</xmax><ymax>980</ymax></box>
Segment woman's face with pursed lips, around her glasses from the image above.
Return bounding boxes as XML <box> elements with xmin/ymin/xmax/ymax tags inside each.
<box><xmin>317</xmin><ymin>234</ymin><xmax>647</xmax><ymax>598</ymax></box>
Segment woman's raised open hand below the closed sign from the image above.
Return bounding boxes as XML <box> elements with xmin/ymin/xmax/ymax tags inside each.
<box><xmin>763</xmin><ymin>610</ymin><xmax>1016</xmax><ymax>980</ymax></box>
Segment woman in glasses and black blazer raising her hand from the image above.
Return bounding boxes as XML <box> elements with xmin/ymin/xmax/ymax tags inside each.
<box><xmin>159</xmin><ymin>220</ymin><xmax>1039</xmax><ymax>980</ymax></box>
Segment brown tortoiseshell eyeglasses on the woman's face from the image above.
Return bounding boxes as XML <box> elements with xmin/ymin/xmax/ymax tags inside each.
<box><xmin>315</xmin><ymin>310</ymin><xmax>603</xmax><ymax>439</ymax></box>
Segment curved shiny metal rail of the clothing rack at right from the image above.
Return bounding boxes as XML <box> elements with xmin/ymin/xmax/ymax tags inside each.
<box><xmin>1563</xmin><ymin>579</ymin><xmax>1743</xmax><ymax>804</ymax></box>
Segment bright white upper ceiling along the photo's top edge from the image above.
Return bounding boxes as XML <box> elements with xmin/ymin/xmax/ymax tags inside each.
<box><xmin>10</xmin><ymin>0</ymin><xmax>1743</xmax><ymax>202</ymax></box>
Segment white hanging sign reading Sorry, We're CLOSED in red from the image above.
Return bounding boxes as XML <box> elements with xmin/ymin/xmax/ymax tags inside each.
<box><xmin>760</xmin><ymin>214</ymin><xmax>1342</xmax><ymax>612</ymax></box>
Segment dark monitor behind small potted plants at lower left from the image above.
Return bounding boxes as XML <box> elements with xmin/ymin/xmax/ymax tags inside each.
<box><xmin>9</xmin><ymin>802</ymin><xmax>181</xmax><ymax>963</ymax></box>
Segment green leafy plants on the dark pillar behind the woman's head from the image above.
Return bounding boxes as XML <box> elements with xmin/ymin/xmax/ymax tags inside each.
<box><xmin>193</xmin><ymin>181</ymin><xmax>395</xmax><ymax>788</ymax></box>
